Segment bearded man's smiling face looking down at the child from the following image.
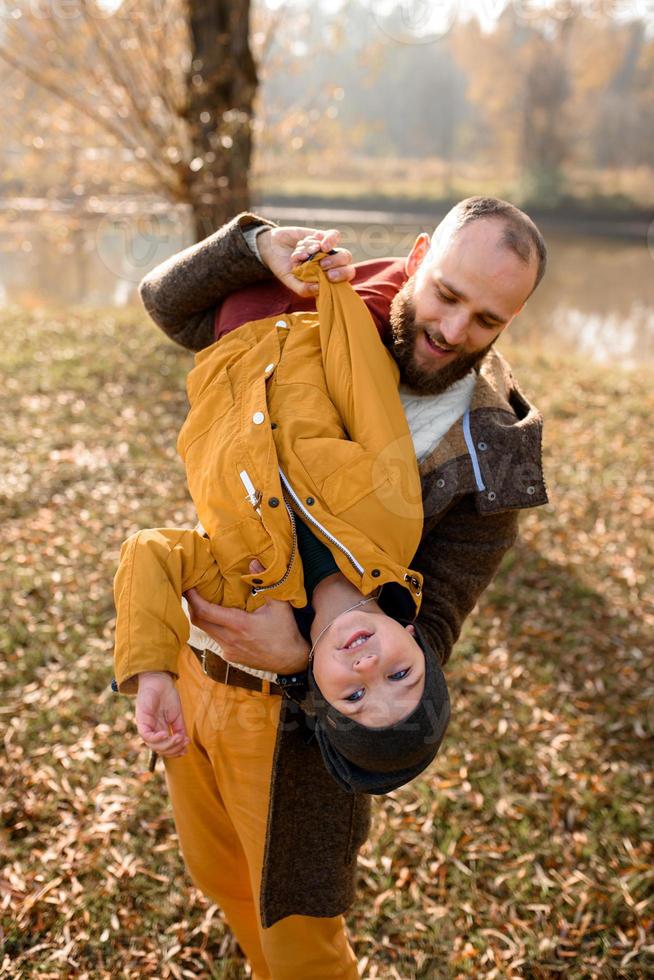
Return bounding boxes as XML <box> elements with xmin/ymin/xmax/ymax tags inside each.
<box><xmin>391</xmin><ymin>218</ymin><xmax>536</xmax><ymax>394</ymax></box>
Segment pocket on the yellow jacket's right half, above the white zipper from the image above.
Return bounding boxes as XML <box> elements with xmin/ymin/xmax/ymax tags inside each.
<box><xmin>293</xmin><ymin>438</ymin><xmax>389</xmax><ymax>514</ymax></box>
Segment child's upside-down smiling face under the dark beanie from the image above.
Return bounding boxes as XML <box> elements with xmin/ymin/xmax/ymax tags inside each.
<box><xmin>313</xmin><ymin>610</ymin><xmax>425</xmax><ymax>728</ymax></box>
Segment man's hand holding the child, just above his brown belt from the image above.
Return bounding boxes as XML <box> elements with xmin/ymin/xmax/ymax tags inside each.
<box><xmin>185</xmin><ymin>560</ymin><xmax>309</xmax><ymax>674</ymax></box>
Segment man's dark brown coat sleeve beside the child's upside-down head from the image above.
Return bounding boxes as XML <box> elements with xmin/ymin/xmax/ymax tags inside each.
<box><xmin>413</xmin><ymin>496</ymin><xmax>518</xmax><ymax>664</ymax></box>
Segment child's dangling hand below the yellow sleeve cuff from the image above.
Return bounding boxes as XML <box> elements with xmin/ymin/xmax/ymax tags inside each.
<box><xmin>136</xmin><ymin>670</ymin><xmax>189</xmax><ymax>758</ymax></box>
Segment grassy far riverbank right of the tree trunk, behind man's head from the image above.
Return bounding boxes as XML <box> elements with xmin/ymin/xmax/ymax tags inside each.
<box><xmin>251</xmin><ymin>157</ymin><xmax>654</xmax><ymax>241</ymax></box>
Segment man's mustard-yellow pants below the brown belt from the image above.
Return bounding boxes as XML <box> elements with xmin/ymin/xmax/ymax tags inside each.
<box><xmin>166</xmin><ymin>648</ymin><xmax>359</xmax><ymax>980</ymax></box>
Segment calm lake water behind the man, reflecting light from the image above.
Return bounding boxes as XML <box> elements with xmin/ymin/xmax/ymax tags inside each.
<box><xmin>0</xmin><ymin>202</ymin><xmax>654</xmax><ymax>367</ymax></box>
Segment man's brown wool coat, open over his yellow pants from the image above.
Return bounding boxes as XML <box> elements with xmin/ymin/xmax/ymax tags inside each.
<box><xmin>140</xmin><ymin>214</ymin><xmax>547</xmax><ymax>926</ymax></box>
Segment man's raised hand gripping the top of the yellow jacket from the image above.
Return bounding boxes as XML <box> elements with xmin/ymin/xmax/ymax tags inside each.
<box><xmin>257</xmin><ymin>228</ymin><xmax>355</xmax><ymax>296</ymax></box>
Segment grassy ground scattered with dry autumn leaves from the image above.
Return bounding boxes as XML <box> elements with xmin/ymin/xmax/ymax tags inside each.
<box><xmin>0</xmin><ymin>311</ymin><xmax>654</xmax><ymax>980</ymax></box>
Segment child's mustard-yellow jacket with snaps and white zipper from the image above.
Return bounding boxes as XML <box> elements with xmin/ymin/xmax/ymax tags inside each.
<box><xmin>115</xmin><ymin>254</ymin><xmax>423</xmax><ymax>690</ymax></box>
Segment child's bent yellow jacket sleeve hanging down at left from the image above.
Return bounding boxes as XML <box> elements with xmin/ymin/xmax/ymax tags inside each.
<box><xmin>114</xmin><ymin>528</ymin><xmax>223</xmax><ymax>694</ymax></box>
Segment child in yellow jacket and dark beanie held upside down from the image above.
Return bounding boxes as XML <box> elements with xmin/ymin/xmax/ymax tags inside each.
<box><xmin>115</xmin><ymin>253</ymin><xmax>449</xmax><ymax>792</ymax></box>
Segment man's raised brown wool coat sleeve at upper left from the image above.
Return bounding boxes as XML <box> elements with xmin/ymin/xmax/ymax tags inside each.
<box><xmin>139</xmin><ymin>212</ymin><xmax>274</xmax><ymax>350</ymax></box>
